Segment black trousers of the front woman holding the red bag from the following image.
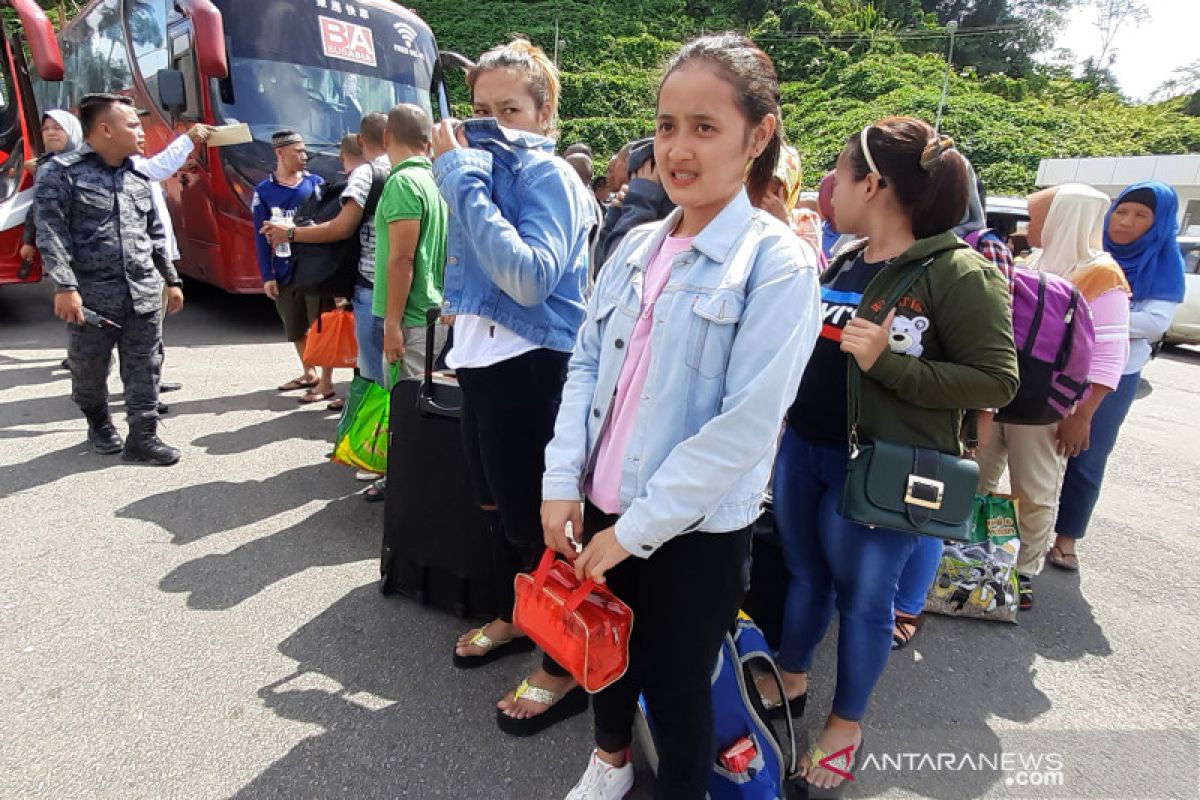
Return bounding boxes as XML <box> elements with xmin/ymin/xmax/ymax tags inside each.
<box><xmin>583</xmin><ymin>503</ymin><xmax>751</xmax><ymax>800</ymax></box>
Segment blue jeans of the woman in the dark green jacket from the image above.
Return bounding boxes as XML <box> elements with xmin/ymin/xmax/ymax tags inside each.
<box><xmin>774</xmin><ymin>428</ymin><xmax>918</xmax><ymax>721</ymax></box>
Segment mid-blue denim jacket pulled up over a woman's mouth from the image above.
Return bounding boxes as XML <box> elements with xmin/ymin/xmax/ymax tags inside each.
<box><xmin>433</xmin><ymin>119</ymin><xmax>595</xmax><ymax>353</ymax></box>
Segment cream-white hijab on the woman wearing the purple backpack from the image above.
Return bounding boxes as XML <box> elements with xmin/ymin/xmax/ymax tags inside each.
<box><xmin>1026</xmin><ymin>184</ymin><xmax>1112</xmax><ymax>278</ymax></box>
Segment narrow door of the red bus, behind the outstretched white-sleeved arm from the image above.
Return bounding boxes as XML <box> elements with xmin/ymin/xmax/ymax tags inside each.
<box><xmin>160</xmin><ymin>18</ymin><xmax>221</xmax><ymax>279</ymax></box>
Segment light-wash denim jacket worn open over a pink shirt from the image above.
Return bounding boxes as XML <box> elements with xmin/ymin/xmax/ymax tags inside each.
<box><xmin>542</xmin><ymin>191</ymin><xmax>821</xmax><ymax>558</ymax></box>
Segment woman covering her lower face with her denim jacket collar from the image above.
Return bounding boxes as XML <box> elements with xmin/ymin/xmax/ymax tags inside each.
<box><xmin>433</xmin><ymin>40</ymin><xmax>595</xmax><ymax>735</ymax></box>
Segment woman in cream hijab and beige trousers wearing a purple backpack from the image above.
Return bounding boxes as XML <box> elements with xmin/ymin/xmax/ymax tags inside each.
<box><xmin>979</xmin><ymin>184</ymin><xmax>1129</xmax><ymax>609</ymax></box>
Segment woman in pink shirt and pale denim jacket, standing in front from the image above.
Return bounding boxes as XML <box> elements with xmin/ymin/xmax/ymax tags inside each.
<box><xmin>541</xmin><ymin>34</ymin><xmax>820</xmax><ymax>800</ymax></box>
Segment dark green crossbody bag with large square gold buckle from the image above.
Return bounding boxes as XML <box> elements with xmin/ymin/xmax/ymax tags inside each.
<box><xmin>838</xmin><ymin>261</ymin><xmax>979</xmax><ymax>542</ymax></box>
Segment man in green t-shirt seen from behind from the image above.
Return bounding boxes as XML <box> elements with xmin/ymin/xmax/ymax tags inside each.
<box><xmin>371</xmin><ymin>103</ymin><xmax>446</xmax><ymax>375</ymax></box>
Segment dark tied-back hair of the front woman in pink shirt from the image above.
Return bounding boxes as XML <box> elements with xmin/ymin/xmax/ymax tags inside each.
<box><xmin>659</xmin><ymin>32</ymin><xmax>782</xmax><ymax>208</ymax></box>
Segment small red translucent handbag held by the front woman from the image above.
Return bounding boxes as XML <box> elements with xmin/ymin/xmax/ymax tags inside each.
<box><xmin>512</xmin><ymin>548</ymin><xmax>634</xmax><ymax>693</ymax></box>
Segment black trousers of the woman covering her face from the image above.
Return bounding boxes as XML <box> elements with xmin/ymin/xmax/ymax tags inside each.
<box><xmin>457</xmin><ymin>349</ymin><xmax>571</xmax><ymax>675</ymax></box>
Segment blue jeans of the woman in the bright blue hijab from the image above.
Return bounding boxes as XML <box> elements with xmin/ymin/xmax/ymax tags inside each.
<box><xmin>1054</xmin><ymin>372</ymin><xmax>1141</xmax><ymax>539</ymax></box>
